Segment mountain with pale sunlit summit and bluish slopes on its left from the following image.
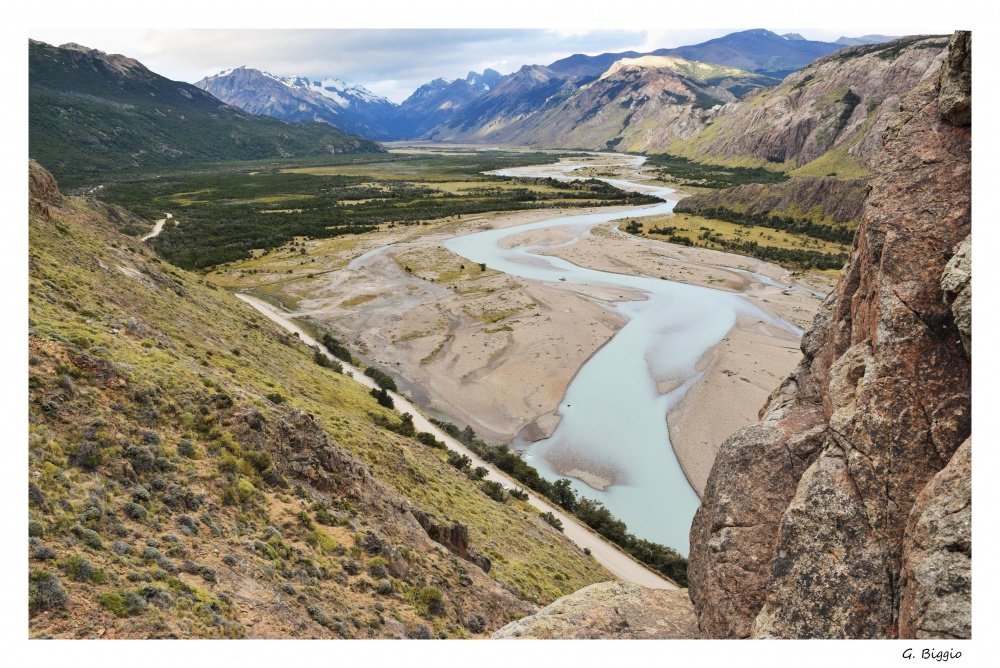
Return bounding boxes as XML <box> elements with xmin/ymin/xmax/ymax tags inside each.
<box><xmin>428</xmin><ymin>56</ymin><xmax>778</xmax><ymax>151</ymax></box>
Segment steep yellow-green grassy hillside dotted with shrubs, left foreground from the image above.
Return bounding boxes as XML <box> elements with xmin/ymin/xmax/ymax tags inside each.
<box><xmin>27</xmin><ymin>160</ymin><xmax>610</xmax><ymax>638</ymax></box>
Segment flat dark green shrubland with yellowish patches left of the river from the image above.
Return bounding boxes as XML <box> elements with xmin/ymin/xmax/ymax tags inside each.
<box><xmin>92</xmin><ymin>153</ymin><xmax>659</xmax><ymax>273</ymax></box>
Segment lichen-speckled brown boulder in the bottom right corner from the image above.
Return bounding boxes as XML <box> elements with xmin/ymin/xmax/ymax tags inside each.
<box><xmin>899</xmin><ymin>438</ymin><xmax>972</xmax><ymax>638</ymax></box>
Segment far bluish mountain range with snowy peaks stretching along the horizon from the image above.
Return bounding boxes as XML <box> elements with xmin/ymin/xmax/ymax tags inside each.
<box><xmin>196</xmin><ymin>29</ymin><xmax>883</xmax><ymax>148</ymax></box>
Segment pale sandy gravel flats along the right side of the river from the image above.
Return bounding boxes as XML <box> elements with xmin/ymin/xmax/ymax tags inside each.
<box><xmin>532</xmin><ymin>219</ymin><xmax>833</xmax><ymax>496</ymax></box>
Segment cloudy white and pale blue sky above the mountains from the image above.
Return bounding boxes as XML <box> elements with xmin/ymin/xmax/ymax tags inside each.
<box><xmin>29</xmin><ymin>23</ymin><xmax>916</xmax><ymax>103</ymax></box>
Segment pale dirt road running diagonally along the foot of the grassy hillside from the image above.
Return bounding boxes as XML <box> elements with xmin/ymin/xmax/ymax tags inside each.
<box><xmin>232</xmin><ymin>292</ymin><xmax>679</xmax><ymax>589</ymax></box>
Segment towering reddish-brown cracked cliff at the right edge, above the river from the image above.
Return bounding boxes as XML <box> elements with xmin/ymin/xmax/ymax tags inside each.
<box><xmin>689</xmin><ymin>32</ymin><xmax>972</xmax><ymax>638</ymax></box>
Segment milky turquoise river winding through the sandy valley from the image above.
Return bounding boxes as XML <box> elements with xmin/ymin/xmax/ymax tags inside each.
<box><xmin>340</xmin><ymin>155</ymin><xmax>799</xmax><ymax>555</ymax></box>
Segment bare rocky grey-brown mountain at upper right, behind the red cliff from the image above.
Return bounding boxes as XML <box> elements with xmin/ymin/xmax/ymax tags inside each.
<box><xmin>667</xmin><ymin>36</ymin><xmax>948</xmax><ymax>178</ymax></box>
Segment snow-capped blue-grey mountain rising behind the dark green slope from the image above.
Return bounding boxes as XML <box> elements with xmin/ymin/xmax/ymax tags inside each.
<box><xmin>195</xmin><ymin>67</ymin><xmax>396</xmax><ymax>139</ymax></box>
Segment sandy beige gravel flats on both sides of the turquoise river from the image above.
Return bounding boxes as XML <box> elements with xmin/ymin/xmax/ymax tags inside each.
<box><xmin>212</xmin><ymin>188</ymin><xmax>833</xmax><ymax>494</ymax></box>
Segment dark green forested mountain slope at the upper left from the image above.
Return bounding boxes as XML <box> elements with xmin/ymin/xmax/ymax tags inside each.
<box><xmin>28</xmin><ymin>40</ymin><xmax>385</xmax><ymax>185</ymax></box>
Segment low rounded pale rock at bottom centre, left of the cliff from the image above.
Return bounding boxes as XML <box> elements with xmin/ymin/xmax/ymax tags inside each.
<box><xmin>493</xmin><ymin>582</ymin><xmax>698</xmax><ymax>640</ymax></box>
